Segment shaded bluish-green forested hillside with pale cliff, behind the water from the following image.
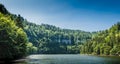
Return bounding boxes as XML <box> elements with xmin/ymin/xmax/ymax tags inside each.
<box><xmin>23</xmin><ymin>17</ymin><xmax>92</xmax><ymax>54</ymax></box>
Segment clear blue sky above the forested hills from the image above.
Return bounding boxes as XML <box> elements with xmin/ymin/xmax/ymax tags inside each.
<box><xmin>0</xmin><ymin>0</ymin><xmax>120</xmax><ymax>31</ymax></box>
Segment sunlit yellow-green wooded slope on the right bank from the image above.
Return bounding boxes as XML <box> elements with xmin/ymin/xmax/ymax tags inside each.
<box><xmin>81</xmin><ymin>22</ymin><xmax>120</xmax><ymax>55</ymax></box>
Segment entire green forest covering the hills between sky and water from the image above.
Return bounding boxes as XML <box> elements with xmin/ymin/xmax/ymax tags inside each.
<box><xmin>0</xmin><ymin>4</ymin><xmax>120</xmax><ymax>59</ymax></box>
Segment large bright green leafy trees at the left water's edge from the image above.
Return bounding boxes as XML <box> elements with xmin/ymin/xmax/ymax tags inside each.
<box><xmin>0</xmin><ymin>13</ymin><xmax>27</xmax><ymax>59</ymax></box>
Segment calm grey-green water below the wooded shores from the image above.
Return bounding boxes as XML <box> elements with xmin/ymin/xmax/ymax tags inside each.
<box><xmin>16</xmin><ymin>54</ymin><xmax>120</xmax><ymax>64</ymax></box>
